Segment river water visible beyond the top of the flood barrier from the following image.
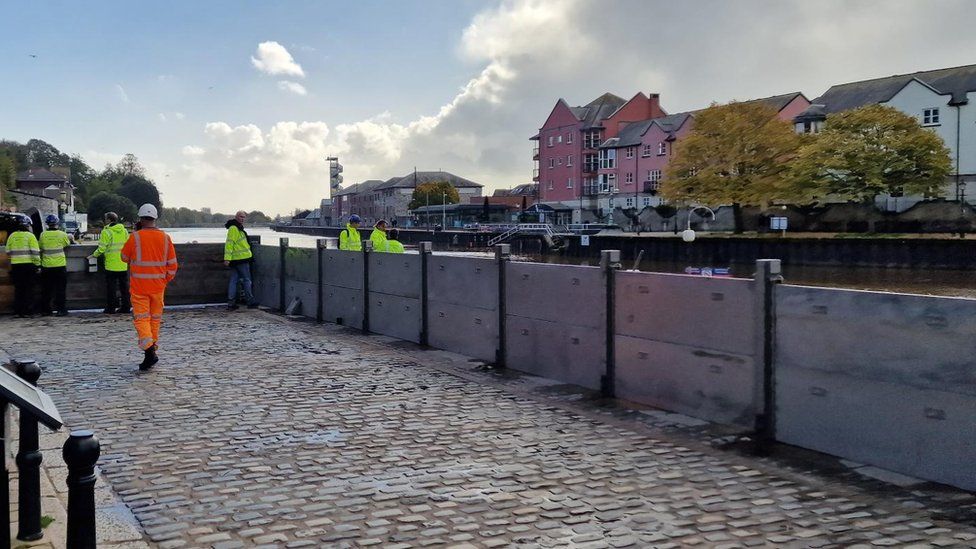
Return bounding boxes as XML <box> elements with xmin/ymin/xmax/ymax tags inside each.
<box><xmin>166</xmin><ymin>227</ymin><xmax>976</xmax><ymax>298</ymax></box>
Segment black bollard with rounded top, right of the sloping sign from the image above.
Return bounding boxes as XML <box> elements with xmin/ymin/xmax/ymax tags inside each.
<box><xmin>61</xmin><ymin>430</ymin><xmax>100</xmax><ymax>549</ymax></box>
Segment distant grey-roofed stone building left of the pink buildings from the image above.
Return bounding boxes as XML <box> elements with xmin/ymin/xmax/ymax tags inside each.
<box><xmin>332</xmin><ymin>171</ymin><xmax>483</xmax><ymax>227</ymax></box>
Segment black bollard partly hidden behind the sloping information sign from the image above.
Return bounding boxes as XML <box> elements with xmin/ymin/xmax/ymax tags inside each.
<box><xmin>15</xmin><ymin>360</ymin><xmax>44</xmax><ymax>541</ymax></box>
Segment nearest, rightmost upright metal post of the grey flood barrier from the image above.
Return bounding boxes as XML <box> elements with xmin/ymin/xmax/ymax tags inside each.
<box><xmin>753</xmin><ymin>259</ymin><xmax>783</xmax><ymax>454</ymax></box>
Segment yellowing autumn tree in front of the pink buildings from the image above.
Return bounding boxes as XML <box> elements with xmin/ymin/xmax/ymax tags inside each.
<box><xmin>661</xmin><ymin>102</ymin><xmax>801</xmax><ymax>232</ymax></box>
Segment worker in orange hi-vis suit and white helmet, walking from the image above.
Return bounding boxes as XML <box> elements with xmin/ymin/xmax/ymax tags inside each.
<box><xmin>122</xmin><ymin>204</ymin><xmax>178</xmax><ymax>370</ymax></box>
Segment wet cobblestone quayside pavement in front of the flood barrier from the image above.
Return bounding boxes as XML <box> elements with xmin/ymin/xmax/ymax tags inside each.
<box><xmin>0</xmin><ymin>309</ymin><xmax>976</xmax><ymax>548</ymax></box>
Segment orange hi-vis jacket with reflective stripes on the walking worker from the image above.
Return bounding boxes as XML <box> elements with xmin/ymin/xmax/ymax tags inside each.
<box><xmin>122</xmin><ymin>227</ymin><xmax>178</xmax><ymax>295</ymax></box>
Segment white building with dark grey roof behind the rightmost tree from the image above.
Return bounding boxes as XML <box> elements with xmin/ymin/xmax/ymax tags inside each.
<box><xmin>793</xmin><ymin>65</ymin><xmax>976</xmax><ymax>210</ymax></box>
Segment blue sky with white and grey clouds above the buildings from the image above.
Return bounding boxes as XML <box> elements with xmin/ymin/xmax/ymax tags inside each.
<box><xmin>0</xmin><ymin>0</ymin><xmax>976</xmax><ymax>213</ymax></box>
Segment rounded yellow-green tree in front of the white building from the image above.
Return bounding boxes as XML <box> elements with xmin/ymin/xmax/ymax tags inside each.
<box><xmin>792</xmin><ymin>105</ymin><xmax>952</xmax><ymax>202</ymax></box>
